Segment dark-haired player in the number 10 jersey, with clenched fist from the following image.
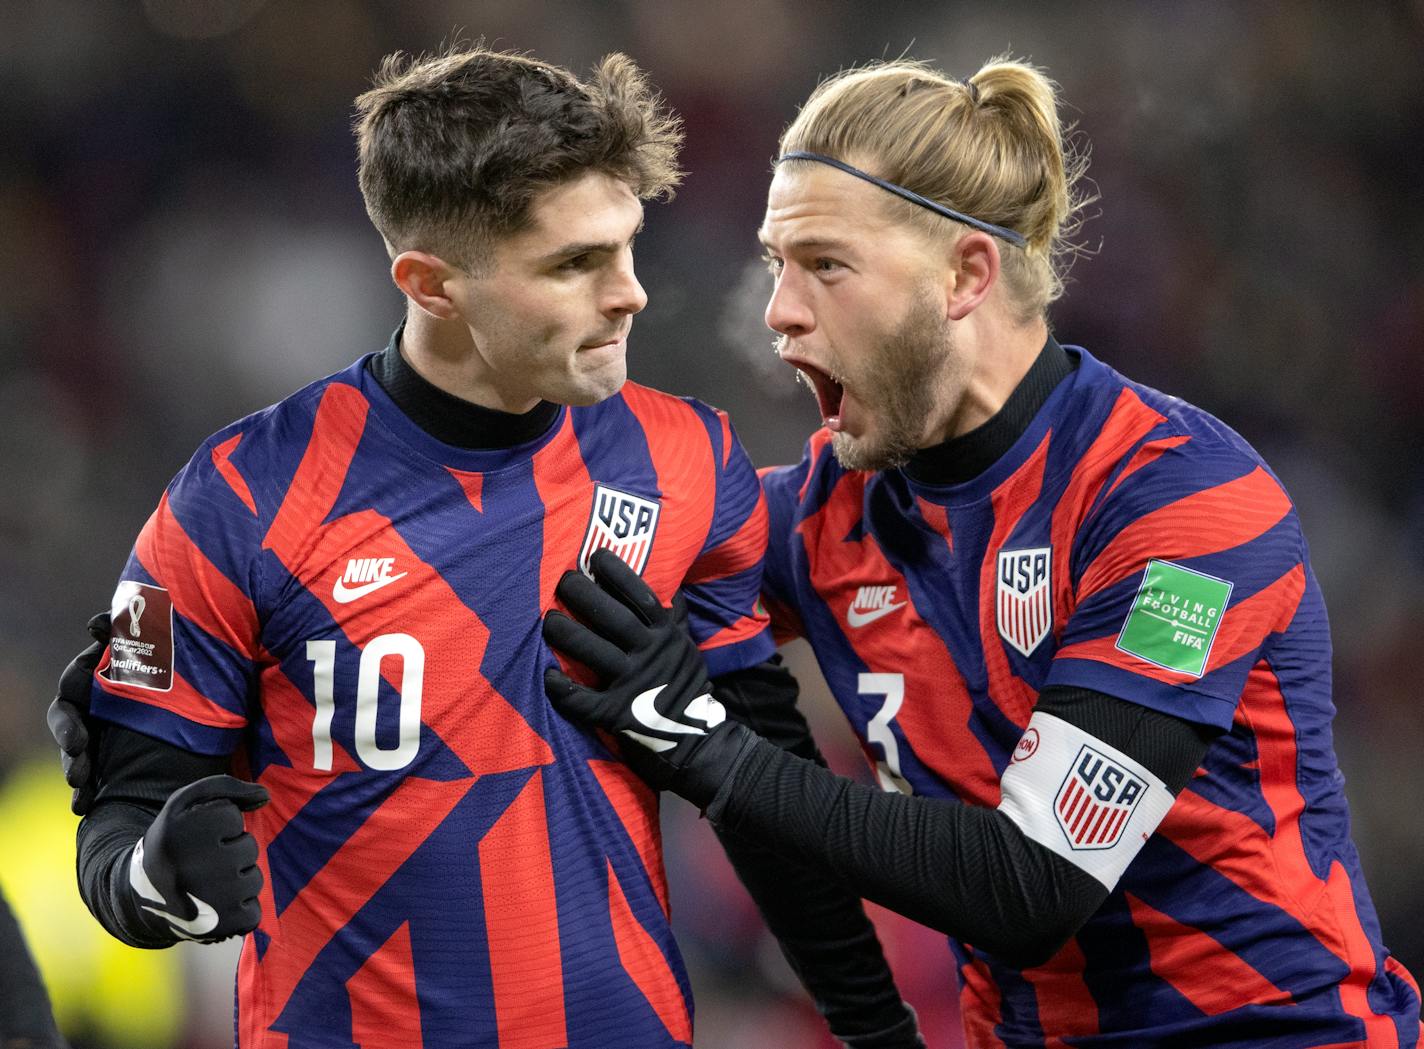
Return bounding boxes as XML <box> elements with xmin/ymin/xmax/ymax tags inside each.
<box><xmin>51</xmin><ymin>48</ymin><xmax>923</xmax><ymax>1049</ymax></box>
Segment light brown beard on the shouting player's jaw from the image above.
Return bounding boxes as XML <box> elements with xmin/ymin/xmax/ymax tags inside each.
<box><xmin>830</xmin><ymin>281</ymin><xmax>965</xmax><ymax>470</ymax></box>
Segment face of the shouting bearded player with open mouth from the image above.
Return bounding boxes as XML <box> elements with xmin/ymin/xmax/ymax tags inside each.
<box><xmin>760</xmin><ymin>164</ymin><xmax>967</xmax><ymax>470</ymax></box>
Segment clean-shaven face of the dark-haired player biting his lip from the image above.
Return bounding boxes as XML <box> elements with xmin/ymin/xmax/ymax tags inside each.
<box><xmin>450</xmin><ymin>171</ymin><xmax>648</xmax><ymax>411</ymax></box>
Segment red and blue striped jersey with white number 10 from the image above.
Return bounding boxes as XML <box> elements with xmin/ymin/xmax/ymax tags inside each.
<box><xmin>86</xmin><ymin>360</ymin><xmax>772</xmax><ymax>1049</ymax></box>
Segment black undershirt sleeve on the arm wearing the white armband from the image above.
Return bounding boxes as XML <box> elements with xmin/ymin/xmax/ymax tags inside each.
<box><xmin>706</xmin><ymin>689</ymin><xmax>1215</xmax><ymax>966</ymax></box>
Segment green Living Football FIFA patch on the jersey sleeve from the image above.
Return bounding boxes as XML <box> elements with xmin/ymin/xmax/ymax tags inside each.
<box><xmin>1118</xmin><ymin>561</ymin><xmax>1232</xmax><ymax>678</ymax></box>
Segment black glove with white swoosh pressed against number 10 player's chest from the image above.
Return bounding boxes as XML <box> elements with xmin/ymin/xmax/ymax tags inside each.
<box><xmin>544</xmin><ymin>549</ymin><xmax>750</xmax><ymax>806</ymax></box>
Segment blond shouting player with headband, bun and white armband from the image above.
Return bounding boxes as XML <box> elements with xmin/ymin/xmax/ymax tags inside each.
<box><xmin>545</xmin><ymin>61</ymin><xmax>1420</xmax><ymax>1048</ymax></box>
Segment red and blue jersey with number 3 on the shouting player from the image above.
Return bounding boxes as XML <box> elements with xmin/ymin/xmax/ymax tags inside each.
<box><xmin>763</xmin><ymin>350</ymin><xmax>1420</xmax><ymax>1048</ymax></box>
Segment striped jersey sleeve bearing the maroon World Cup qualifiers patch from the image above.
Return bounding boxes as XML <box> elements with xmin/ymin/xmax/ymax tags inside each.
<box><xmin>91</xmin><ymin>431</ymin><xmax>262</xmax><ymax>754</ymax></box>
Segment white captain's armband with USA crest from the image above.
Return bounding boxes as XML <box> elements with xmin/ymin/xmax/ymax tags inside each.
<box><xmin>998</xmin><ymin>710</ymin><xmax>1175</xmax><ymax>892</ymax></box>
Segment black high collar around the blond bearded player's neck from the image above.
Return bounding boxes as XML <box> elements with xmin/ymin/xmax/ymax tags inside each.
<box><xmin>899</xmin><ymin>336</ymin><xmax>1095</xmax><ymax>505</ymax></box>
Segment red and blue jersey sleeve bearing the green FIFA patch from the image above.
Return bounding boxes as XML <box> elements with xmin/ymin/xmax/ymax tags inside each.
<box><xmin>1045</xmin><ymin>436</ymin><xmax>1323</xmax><ymax>729</ymax></box>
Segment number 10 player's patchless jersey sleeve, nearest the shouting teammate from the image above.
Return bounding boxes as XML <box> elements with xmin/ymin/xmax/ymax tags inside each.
<box><xmin>682</xmin><ymin>404</ymin><xmax>775</xmax><ymax>678</ymax></box>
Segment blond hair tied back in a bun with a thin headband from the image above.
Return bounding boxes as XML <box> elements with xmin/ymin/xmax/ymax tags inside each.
<box><xmin>780</xmin><ymin>57</ymin><xmax>1088</xmax><ymax>320</ymax></box>
